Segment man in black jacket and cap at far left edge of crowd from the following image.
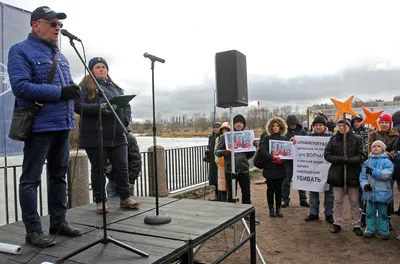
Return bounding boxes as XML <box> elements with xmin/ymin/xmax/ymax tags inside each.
<box><xmin>203</xmin><ymin>122</ymin><xmax>221</xmax><ymax>201</ymax></box>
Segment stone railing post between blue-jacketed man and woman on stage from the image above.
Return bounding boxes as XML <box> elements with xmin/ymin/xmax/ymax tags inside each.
<box><xmin>67</xmin><ymin>150</ymin><xmax>90</xmax><ymax>208</ymax></box>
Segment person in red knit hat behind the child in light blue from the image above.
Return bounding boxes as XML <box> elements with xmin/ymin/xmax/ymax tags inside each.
<box><xmin>368</xmin><ymin>114</ymin><xmax>399</xmax><ymax>230</ymax></box>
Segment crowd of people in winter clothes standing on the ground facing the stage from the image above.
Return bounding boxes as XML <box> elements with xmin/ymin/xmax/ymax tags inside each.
<box><xmin>205</xmin><ymin>111</ymin><xmax>400</xmax><ymax>240</ymax></box>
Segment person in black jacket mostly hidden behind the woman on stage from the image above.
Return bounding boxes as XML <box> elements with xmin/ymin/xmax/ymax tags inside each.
<box><xmin>106</xmin><ymin>129</ymin><xmax>142</xmax><ymax>201</ymax></box>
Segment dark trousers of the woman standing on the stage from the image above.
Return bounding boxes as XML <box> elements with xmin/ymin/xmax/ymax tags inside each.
<box><xmin>85</xmin><ymin>145</ymin><xmax>130</xmax><ymax>203</ymax></box>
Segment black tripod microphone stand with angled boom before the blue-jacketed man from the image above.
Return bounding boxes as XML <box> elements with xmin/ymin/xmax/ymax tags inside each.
<box><xmin>55</xmin><ymin>39</ymin><xmax>149</xmax><ymax>264</ymax></box>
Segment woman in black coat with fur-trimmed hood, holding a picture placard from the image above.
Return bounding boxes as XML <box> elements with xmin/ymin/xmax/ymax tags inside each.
<box><xmin>260</xmin><ymin>117</ymin><xmax>287</xmax><ymax>217</ymax></box>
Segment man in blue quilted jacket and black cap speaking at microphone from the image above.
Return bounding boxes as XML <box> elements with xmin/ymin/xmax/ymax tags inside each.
<box><xmin>8</xmin><ymin>6</ymin><xmax>81</xmax><ymax>247</ymax></box>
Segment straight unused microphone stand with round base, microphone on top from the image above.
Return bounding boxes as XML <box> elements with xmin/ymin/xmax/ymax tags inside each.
<box><xmin>144</xmin><ymin>53</ymin><xmax>171</xmax><ymax>225</ymax></box>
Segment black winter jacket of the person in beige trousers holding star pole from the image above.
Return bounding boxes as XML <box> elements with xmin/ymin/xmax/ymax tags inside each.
<box><xmin>324</xmin><ymin>131</ymin><xmax>364</xmax><ymax>187</ymax></box>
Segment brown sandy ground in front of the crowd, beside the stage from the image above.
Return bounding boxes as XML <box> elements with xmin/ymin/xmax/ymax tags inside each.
<box><xmin>196</xmin><ymin>172</ymin><xmax>400</xmax><ymax>264</ymax></box>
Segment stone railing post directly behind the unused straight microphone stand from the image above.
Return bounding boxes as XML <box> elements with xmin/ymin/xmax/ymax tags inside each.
<box><xmin>148</xmin><ymin>145</ymin><xmax>169</xmax><ymax>197</ymax></box>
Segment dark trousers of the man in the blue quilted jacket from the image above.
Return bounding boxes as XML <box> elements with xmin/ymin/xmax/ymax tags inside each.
<box><xmin>19</xmin><ymin>130</ymin><xmax>69</xmax><ymax>232</ymax></box>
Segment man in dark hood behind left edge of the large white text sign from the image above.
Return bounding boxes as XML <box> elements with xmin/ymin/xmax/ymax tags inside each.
<box><xmin>282</xmin><ymin>115</ymin><xmax>310</xmax><ymax>208</ymax></box>
